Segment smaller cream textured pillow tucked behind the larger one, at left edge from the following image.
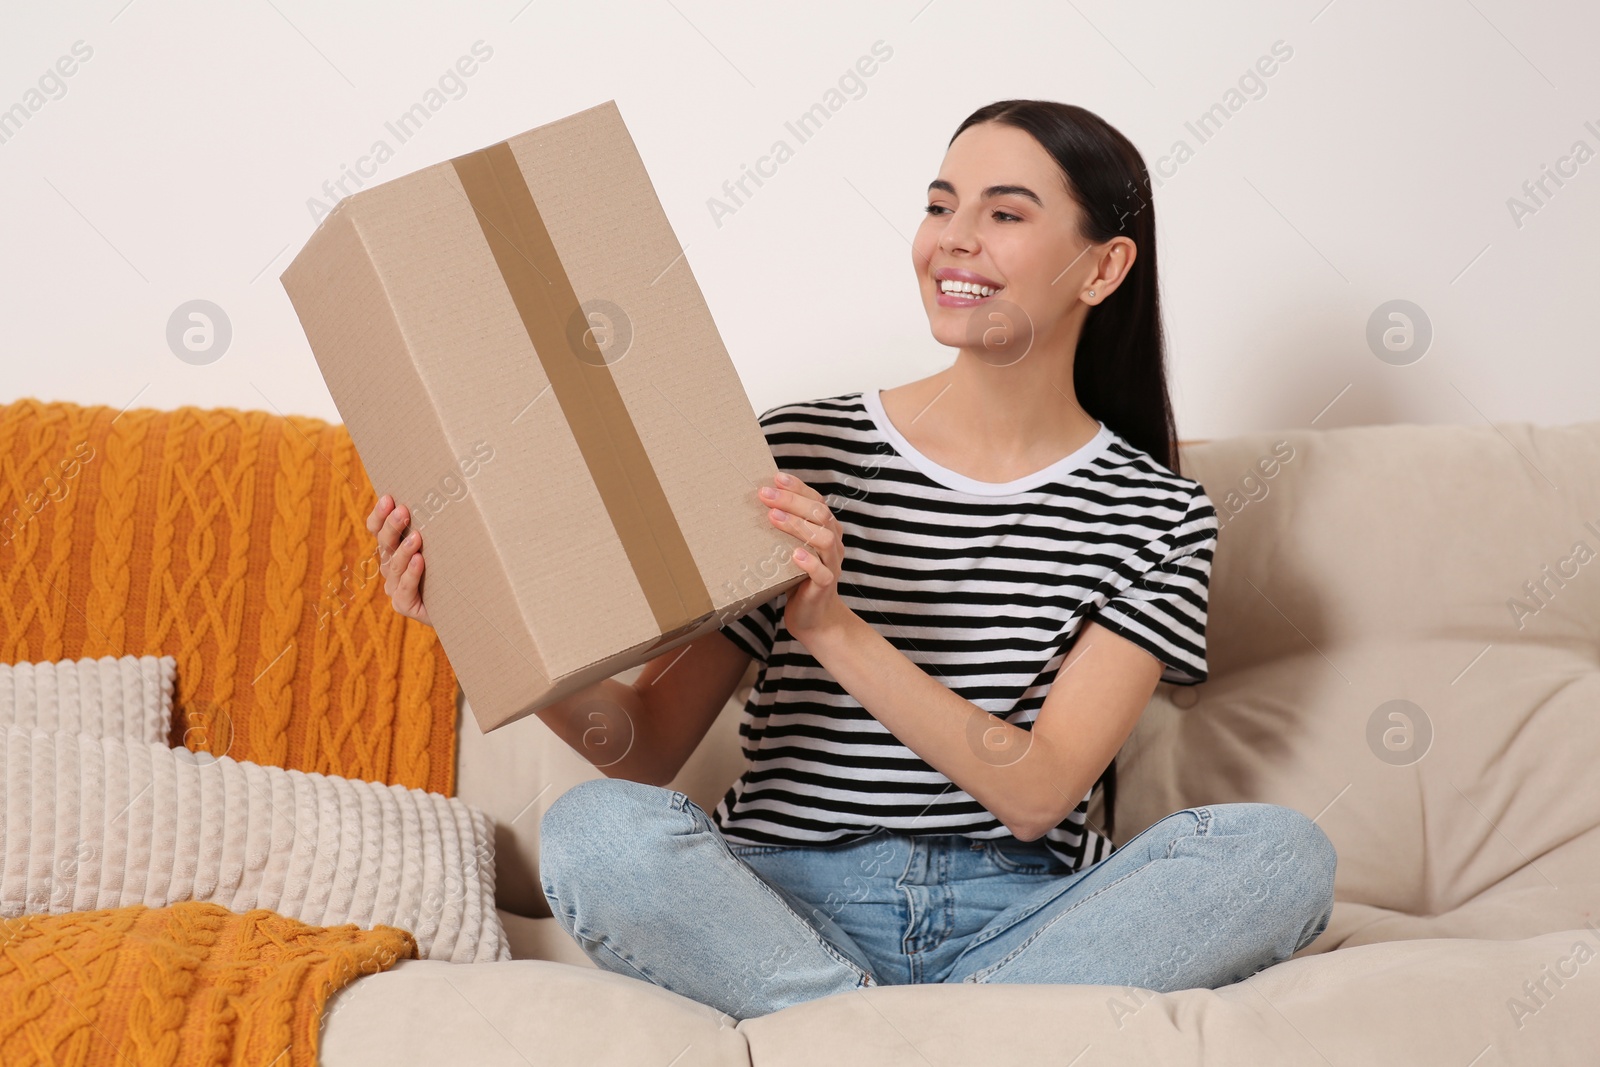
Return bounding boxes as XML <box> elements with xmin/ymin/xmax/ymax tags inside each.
<box><xmin>0</xmin><ymin>656</ymin><xmax>178</xmax><ymax>744</ymax></box>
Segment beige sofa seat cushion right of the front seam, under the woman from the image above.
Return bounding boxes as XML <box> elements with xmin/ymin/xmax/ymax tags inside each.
<box><xmin>732</xmin><ymin>929</ymin><xmax>1600</xmax><ymax>1067</ymax></box>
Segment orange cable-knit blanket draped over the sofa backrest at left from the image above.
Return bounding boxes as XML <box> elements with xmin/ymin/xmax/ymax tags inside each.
<box><xmin>0</xmin><ymin>400</ymin><xmax>456</xmax><ymax>795</ymax></box>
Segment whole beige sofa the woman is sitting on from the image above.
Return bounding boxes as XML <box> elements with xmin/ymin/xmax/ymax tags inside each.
<box><xmin>322</xmin><ymin>422</ymin><xmax>1600</xmax><ymax>1067</ymax></box>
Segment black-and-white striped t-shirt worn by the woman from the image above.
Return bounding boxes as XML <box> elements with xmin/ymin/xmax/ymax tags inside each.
<box><xmin>712</xmin><ymin>390</ymin><xmax>1218</xmax><ymax>870</ymax></box>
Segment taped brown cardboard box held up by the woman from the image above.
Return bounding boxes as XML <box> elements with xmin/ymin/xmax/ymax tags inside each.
<box><xmin>282</xmin><ymin>101</ymin><xmax>805</xmax><ymax>729</ymax></box>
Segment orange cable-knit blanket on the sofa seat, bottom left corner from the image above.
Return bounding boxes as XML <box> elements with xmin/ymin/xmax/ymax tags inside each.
<box><xmin>0</xmin><ymin>902</ymin><xmax>416</xmax><ymax>1067</ymax></box>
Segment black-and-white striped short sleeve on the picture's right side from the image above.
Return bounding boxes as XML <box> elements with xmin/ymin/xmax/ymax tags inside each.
<box><xmin>1091</xmin><ymin>485</ymin><xmax>1218</xmax><ymax>685</ymax></box>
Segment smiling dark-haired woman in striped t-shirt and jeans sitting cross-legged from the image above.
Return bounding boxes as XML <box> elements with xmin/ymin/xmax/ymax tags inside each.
<box><xmin>368</xmin><ymin>101</ymin><xmax>1336</xmax><ymax>1019</ymax></box>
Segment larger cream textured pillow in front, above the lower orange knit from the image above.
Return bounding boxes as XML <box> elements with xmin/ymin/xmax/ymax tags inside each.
<box><xmin>0</xmin><ymin>726</ymin><xmax>510</xmax><ymax>963</ymax></box>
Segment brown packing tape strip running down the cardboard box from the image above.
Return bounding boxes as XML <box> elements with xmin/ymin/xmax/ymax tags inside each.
<box><xmin>451</xmin><ymin>141</ymin><xmax>714</xmax><ymax>640</ymax></box>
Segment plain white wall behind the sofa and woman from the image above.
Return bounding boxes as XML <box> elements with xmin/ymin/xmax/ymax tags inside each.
<box><xmin>0</xmin><ymin>0</ymin><xmax>1600</xmax><ymax>438</ymax></box>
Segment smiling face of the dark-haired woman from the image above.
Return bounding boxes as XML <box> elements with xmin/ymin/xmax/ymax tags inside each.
<box><xmin>912</xmin><ymin>122</ymin><xmax>1133</xmax><ymax>365</ymax></box>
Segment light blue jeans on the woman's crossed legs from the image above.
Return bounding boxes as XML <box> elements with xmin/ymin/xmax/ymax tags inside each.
<box><xmin>539</xmin><ymin>777</ymin><xmax>1336</xmax><ymax>1019</ymax></box>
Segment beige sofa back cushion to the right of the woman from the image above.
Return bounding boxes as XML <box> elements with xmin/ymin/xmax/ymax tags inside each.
<box><xmin>1117</xmin><ymin>422</ymin><xmax>1600</xmax><ymax>952</ymax></box>
